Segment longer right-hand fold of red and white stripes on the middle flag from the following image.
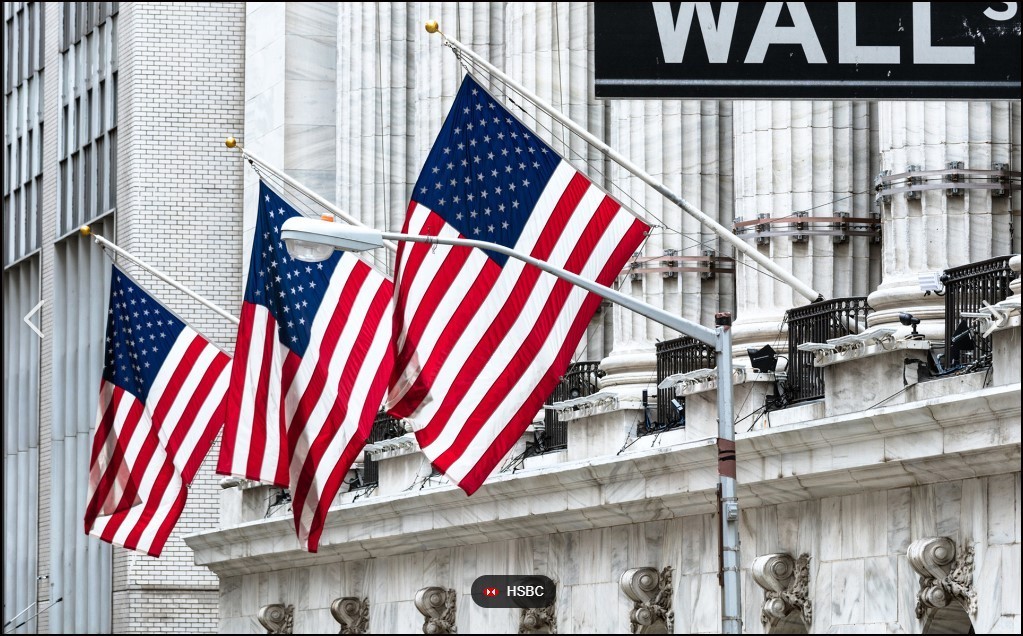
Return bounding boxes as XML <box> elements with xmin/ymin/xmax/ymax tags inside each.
<box><xmin>283</xmin><ymin>256</ymin><xmax>394</xmax><ymax>552</ymax></box>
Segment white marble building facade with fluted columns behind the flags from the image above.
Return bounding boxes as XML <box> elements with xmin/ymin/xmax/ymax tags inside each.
<box><xmin>182</xmin><ymin>3</ymin><xmax>1020</xmax><ymax>633</ymax></box>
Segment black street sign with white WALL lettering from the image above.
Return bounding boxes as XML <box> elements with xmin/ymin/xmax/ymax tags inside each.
<box><xmin>593</xmin><ymin>2</ymin><xmax>1021</xmax><ymax>99</ymax></box>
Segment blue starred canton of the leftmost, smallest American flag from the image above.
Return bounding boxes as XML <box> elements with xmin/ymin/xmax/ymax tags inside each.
<box><xmin>103</xmin><ymin>265</ymin><xmax>185</xmax><ymax>402</ymax></box>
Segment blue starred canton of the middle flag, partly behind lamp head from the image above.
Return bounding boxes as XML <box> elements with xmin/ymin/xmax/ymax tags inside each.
<box><xmin>246</xmin><ymin>181</ymin><xmax>342</xmax><ymax>357</ymax></box>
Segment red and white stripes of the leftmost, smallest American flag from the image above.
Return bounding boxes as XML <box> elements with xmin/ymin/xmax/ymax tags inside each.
<box><xmin>85</xmin><ymin>326</ymin><xmax>230</xmax><ymax>556</ymax></box>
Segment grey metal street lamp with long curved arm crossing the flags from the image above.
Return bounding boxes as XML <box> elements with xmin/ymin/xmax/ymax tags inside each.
<box><xmin>280</xmin><ymin>217</ymin><xmax>742</xmax><ymax>634</ymax></box>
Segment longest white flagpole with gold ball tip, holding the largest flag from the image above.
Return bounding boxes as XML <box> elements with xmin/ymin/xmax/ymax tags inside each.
<box><xmin>427</xmin><ymin>20</ymin><xmax>825</xmax><ymax>302</ymax></box>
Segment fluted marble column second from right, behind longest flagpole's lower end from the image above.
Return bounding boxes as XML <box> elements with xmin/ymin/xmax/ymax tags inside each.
<box><xmin>732</xmin><ymin>101</ymin><xmax>880</xmax><ymax>365</ymax></box>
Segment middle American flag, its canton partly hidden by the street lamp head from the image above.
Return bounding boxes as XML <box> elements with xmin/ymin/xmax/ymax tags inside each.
<box><xmin>217</xmin><ymin>182</ymin><xmax>394</xmax><ymax>552</ymax></box>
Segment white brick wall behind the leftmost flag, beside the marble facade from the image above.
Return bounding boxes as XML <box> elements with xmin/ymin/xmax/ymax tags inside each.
<box><xmin>114</xmin><ymin>3</ymin><xmax>244</xmax><ymax>633</ymax></box>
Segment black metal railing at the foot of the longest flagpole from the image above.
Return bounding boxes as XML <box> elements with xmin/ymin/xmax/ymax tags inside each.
<box><xmin>786</xmin><ymin>297</ymin><xmax>873</xmax><ymax>404</ymax></box>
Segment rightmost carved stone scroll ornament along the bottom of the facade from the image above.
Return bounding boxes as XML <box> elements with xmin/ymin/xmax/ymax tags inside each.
<box><xmin>906</xmin><ymin>537</ymin><xmax>977</xmax><ymax>619</ymax></box>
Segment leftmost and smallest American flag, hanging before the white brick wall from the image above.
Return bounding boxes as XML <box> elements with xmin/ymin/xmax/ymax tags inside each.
<box><xmin>85</xmin><ymin>266</ymin><xmax>231</xmax><ymax>556</ymax></box>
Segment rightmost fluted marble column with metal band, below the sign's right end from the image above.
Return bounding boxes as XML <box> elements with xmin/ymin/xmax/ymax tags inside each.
<box><xmin>869</xmin><ymin>101</ymin><xmax>1020</xmax><ymax>340</ymax></box>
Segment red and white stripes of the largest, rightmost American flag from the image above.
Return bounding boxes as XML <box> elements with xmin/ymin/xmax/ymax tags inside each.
<box><xmin>388</xmin><ymin>161</ymin><xmax>650</xmax><ymax>494</ymax></box>
